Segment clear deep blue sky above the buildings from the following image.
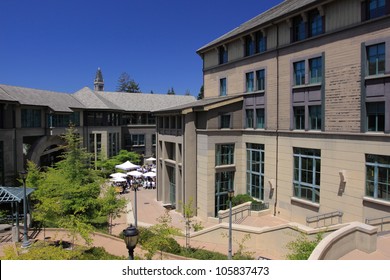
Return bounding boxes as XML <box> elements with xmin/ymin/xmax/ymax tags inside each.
<box><xmin>0</xmin><ymin>0</ymin><xmax>282</xmax><ymax>96</ymax></box>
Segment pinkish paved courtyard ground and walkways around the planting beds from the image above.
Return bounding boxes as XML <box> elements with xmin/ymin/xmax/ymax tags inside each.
<box><xmin>0</xmin><ymin>185</ymin><xmax>390</xmax><ymax>260</ymax></box>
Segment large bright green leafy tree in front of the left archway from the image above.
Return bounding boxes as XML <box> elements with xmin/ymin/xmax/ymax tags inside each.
<box><xmin>31</xmin><ymin>127</ymin><xmax>123</xmax><ymax>243</ymax></box>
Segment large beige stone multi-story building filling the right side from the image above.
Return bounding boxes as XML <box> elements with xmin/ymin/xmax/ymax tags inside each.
<box><xmin>157</xmin><ymin>0</ymin><xmax>390</xmax><ymax>228</ymax></box>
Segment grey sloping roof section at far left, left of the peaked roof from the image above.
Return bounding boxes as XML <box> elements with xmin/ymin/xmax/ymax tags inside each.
<box><xmin>0</xmin><ymin>85</ymin><xmax>84</xmax><ymax>112</ymax></box>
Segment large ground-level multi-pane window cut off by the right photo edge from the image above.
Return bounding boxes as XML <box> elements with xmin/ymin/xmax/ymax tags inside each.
<box><xmin>366</xmin><ymin>155</ymin><xmax>390</xmax><ymax>201</ymax></box>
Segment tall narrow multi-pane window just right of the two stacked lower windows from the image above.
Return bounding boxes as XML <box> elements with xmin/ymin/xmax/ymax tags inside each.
<box><xmin>246</xmin><ymin>143</ymin><xmax>264</xmax><ymax>200</ymax></box>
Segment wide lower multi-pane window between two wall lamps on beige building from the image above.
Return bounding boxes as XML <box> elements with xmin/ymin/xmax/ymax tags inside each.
<box><xmin>293</xmin><ymin>148</ymin><xmax>321</xmax><ymax>203</ymax></box>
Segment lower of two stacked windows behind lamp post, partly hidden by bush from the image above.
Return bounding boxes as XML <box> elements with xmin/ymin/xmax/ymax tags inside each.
<box><xmin>215</xmin><ymin>171</ymin><xmax>234</xmax><ymax>214</ymax></box>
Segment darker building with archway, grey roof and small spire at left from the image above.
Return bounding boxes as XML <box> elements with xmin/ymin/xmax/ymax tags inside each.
<box><xmin>0</xmin><ymin>69</ymin><xmax>195</xmax><ymax>185</ymax></box>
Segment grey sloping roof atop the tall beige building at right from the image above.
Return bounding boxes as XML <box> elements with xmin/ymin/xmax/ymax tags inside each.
<box><xmin>197</xmin><ymin>0</ymin><xmax>321</xmax><ymax>54</ymax></box>
